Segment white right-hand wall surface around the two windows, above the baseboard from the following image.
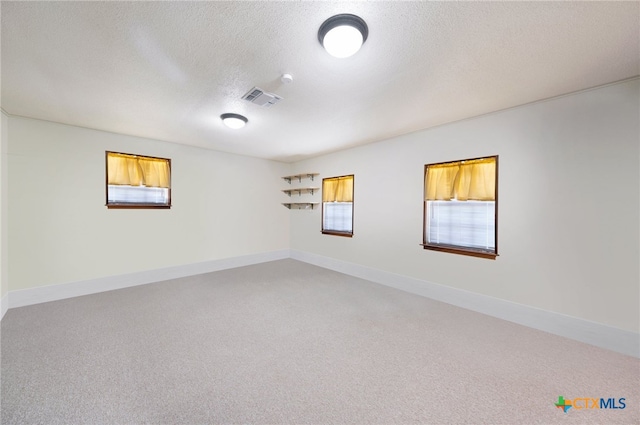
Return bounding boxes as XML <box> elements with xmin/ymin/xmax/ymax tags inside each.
<box><xmin>291</xmin><ymin>79</ymin><xmax>640</xmax><ymax>332</ymax></box>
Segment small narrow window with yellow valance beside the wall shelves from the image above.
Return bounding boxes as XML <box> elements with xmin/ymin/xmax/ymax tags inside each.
<box><xmin>322</xmin><ymin>175</ymin><xmax>353</xmax><ymax>237</ymax></box>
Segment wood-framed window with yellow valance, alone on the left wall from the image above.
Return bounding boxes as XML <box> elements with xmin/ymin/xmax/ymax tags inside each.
<box><xmin>106</xmin><ymin>152</ymin><xmax>171</xmax><ymax>208</ymax></box>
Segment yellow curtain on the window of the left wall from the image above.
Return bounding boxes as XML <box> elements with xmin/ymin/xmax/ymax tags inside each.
<box><xmin>107</xmin><ymin>152</ymin><xmax>171</xmax><ymax>188</ymax></box>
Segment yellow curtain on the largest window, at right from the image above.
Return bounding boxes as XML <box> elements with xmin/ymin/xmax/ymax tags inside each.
<box><xmin>425</xmin><ymin>157</ymin><xmax>496</xmax><ymax>201</ymax></box>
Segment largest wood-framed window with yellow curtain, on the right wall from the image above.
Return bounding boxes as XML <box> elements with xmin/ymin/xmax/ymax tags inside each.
<box><xmin>422</xmin><ymin>156</ymin><xmax>498</xmax><ymax>259</ymax></box>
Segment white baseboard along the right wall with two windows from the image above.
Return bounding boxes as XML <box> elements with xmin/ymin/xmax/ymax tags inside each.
<box><xmin>291</xmin><ymin>250</ymin><xmax>640</xmax><ymax>357</ymax></box>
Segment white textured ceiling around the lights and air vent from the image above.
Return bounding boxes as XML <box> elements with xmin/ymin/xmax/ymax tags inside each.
<box><xmin>1</xmin><ymin>1</ymin><xmax>640</xmax><ymax>161</ymax></box>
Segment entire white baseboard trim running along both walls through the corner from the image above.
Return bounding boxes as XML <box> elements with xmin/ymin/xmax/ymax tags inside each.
<box><xmin>6</xmin><ymin>249</ymin><xmax>640</xmax><ymax>358</ymax></box>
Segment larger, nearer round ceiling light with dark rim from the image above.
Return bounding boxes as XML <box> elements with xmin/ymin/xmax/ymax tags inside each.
<box><xmin>318</xmin><ymin>13</ymin><xmax>369</xmax><ymax>58</ymax></box>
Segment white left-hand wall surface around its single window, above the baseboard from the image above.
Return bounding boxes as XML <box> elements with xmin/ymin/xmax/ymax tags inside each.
<box><xmin>8</xmin><ymin>117</ymin><xmax>290</xmax><ymax>291</ymax></box>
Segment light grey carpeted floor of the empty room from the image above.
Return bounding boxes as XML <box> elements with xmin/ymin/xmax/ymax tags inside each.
<box><xmin>1</xmin><ymin>260</ymin><xmax>640</xmax><ymax>425</ymax></box>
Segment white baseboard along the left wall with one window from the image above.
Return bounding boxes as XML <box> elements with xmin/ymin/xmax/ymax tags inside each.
<box><xmin>8</xmin><ymin>249</ymin><xmax>289</xmax><ymax>314</ymax></box>
